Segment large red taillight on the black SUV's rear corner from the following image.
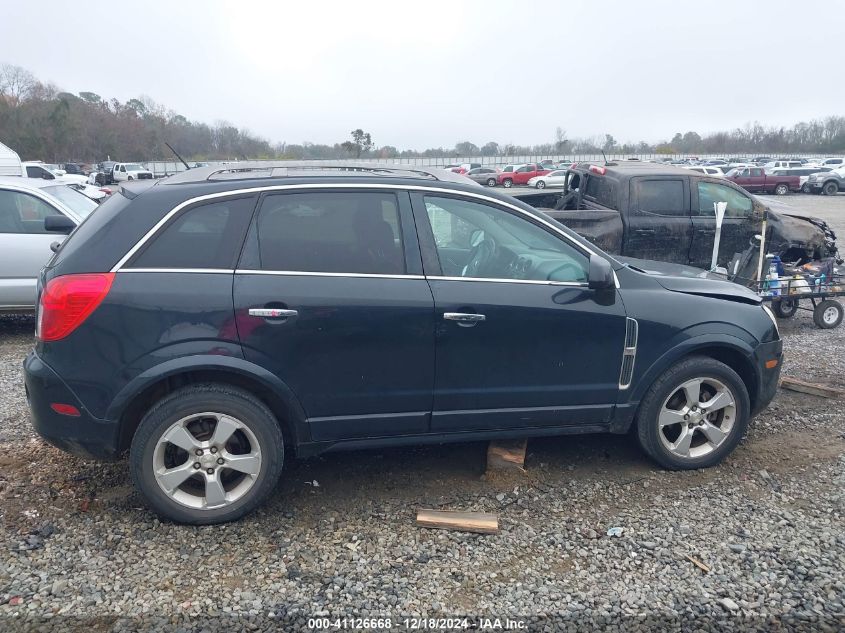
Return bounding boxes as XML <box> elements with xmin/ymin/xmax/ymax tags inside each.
<box><xmin>35</xmin><ymin>273</ymin><xmax>114</xmax><ymax>341</ymax></box>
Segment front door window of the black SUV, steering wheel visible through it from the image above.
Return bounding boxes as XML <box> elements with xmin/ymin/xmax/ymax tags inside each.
<box><xmin>424</xmin><ymin>196</ymin><xmax>590</xmax><ymax>282</ymax></box>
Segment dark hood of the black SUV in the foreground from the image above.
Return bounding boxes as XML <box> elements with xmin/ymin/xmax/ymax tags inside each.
<box><xmin>615</xmin><ymin>257</ymin><xmax>763</xmax><ymax>305</ymax></box>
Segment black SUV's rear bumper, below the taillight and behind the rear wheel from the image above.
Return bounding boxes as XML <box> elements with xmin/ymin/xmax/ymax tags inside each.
<box><xmin>23</xmin><ymin>351</ymin><xmax>118</xmax><ymax>460</ymax></box>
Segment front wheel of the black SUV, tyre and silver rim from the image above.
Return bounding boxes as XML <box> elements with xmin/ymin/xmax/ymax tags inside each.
<box><xmin>636</xmin><ymin>356</ymin><xmax>751</xmax><ymax>470</ymax></box>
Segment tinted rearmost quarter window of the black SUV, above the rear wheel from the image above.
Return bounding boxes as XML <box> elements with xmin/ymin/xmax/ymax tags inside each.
<box><xmin>128</xmin><ymin>196</ymin><xmax>255</xmax><ymax>270</ymax></box>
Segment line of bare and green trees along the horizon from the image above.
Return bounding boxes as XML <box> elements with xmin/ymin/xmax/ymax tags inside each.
<box><xmin>0</xmin><ymin>64</ymin><xmax>845</xmax><ymax>162</ymax></box>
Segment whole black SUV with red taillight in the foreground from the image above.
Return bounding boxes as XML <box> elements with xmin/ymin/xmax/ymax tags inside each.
<box><xmin>25</xmin><ymin>163</ymin><xmax>782</xmax><ymax>523</ymax></box>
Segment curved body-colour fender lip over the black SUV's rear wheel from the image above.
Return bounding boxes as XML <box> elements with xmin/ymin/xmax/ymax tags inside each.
<box><xmin>106</xmin><ymin>354</ymin><xmax>310</xmax><ymax>443</ymax></box>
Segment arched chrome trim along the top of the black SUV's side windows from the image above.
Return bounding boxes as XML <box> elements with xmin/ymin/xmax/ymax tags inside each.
<box><xmin>111</xmin><ymin>183</ymin><xmax>599</xmax><ymax>274</ymax></box>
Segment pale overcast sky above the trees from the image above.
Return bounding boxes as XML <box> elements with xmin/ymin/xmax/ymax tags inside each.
<box><xmin>0</xmin><ymin>0</ymin><xmax>845</xmax><ymax>149</ymax></box>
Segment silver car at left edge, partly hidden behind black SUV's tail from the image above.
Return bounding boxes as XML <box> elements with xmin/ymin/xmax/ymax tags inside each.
<box><xmin>0</xmin><ymin>176</ymin><xmax>98</xmax><ymax>312</ymax></box>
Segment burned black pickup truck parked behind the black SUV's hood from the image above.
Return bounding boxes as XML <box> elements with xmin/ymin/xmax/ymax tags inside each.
<box><xmin>516</xmin><ymin>163</ymin><xmax>838</xmax><ymax>285</ymax></box>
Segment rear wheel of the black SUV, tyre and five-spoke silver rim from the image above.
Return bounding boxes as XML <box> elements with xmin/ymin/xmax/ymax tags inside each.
<box><xmin>129</xmin><ymin>383</ymin><xmax>284</xmax><ymax>525</ymax></box>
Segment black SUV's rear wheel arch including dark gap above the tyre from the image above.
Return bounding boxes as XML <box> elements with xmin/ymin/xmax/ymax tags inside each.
<box><xmin>107</xmin><ymin>356</ymin><xmax>310</xmax><ymax>452</ymax></box>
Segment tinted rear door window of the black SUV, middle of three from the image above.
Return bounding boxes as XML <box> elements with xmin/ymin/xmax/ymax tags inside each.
<box><xmin>256</xmin><ymin>192</ymin><xmax>405</xmax><ymax>275</ymax></box>
